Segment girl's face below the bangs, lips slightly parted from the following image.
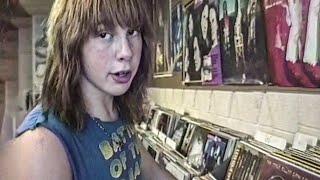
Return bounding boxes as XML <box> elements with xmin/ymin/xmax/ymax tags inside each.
<box><xmin>81</xmin><ymin>25</ymin><xmax>142</xmax><ymax>96</ymax></box>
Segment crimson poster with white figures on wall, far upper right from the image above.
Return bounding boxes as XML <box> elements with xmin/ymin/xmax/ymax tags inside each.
<box><xmin>263</xmin><ymin>0</ymin><xmax>320</xmax><ymax>87</ymax></box>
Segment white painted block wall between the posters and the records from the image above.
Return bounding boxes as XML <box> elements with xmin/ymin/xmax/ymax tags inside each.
<box><xmin>148</xmin><ymin>88</ymin><xmax>320</xmax><ymax>143</ymax></box>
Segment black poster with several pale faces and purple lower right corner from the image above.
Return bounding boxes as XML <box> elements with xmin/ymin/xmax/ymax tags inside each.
<box><xmin>183</xmin><ymin>0</ymin><xmax>222</xmax><ymax>85</ymax></box>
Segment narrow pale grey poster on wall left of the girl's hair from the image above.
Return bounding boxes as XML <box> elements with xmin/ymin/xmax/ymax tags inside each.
<box><xmin>32</xmin><ymin>16</ymin><xmax>48</xmax><ymax>96</ymax></box>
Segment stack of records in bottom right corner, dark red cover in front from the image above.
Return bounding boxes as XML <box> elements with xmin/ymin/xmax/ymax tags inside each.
<box><xmin>226</xmin><ymin>140</ymin><xmax>320</xmax><ymax>180</ymax></box>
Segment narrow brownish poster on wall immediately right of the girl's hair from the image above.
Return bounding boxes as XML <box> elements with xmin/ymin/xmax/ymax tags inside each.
<box><xmin>153</xmin><ymin>0</ymin><xmax>173</xmax><ymax>78</ymax></box>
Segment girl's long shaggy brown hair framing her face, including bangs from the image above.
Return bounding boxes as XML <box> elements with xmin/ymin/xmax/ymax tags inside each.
<box><xmin>41</xmin><ymin>0</ymin><xmax>153</xmax><ymax>130</ymax></box>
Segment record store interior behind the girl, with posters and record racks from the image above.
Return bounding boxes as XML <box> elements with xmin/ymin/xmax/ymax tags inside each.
<box><xmin>0</xmin><ymin>0</ymin><xmax>320</xmax><ymax>180</ymax></box>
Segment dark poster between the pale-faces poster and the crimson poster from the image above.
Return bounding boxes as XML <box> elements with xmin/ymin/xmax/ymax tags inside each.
<box><xmin>219</xmin><ymin>0</ymin><xmax>269</xmax><ymax>84</ymax></box>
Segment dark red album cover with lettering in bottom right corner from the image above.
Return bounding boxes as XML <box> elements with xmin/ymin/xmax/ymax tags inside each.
<box><xmin>259</xmin><ymin>157</ymin><xmax>320</xmax><ymax>180</ymax></box>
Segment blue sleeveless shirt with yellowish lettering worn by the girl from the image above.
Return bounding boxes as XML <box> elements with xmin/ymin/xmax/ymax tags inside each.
<box><xmin>17</xmin><ymin>105</ymin><xmax>141</xmax><ymax>180</ymax></box>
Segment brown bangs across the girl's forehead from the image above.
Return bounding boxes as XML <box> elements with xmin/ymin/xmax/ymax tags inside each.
<box><xmin>91</xmin><ymin>0</ymin><xmax>149</xmax><ymax>32</ymax></box>
